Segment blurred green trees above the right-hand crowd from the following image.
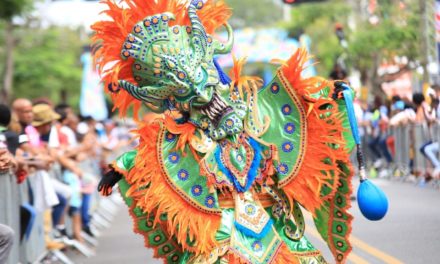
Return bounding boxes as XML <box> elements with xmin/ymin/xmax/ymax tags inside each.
<box><xmin>285</xmin><ymin>0</ymin><xmax>421</xmax><ymax>96</ymax></box>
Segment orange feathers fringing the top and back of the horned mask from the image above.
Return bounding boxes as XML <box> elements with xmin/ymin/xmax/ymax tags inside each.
<box><xmin>92</xmin><ymin>0</ymin><xmax>232</xmax><ymax>118</ymax></box>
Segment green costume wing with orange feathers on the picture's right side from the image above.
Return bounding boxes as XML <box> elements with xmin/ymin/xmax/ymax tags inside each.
<box><xmin>258</xmin><ymin>49</ymin><xmax>354</xmax><ymax>262</ymax></box>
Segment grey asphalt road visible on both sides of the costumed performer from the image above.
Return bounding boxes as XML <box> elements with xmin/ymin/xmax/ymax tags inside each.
<box><xmin>75</xmin><ymin>177</ymin><xmax>440</xmax><ymax>264</ymax></box>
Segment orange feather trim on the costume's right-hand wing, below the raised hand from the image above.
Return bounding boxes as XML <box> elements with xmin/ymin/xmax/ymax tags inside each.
<box><xmin>281</xmin><ymin>49</ymin><xmax>353</xmax><ymax>258</ymax></box>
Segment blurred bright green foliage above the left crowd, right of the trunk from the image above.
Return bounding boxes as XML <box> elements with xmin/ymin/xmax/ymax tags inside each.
<box><xmin>13</xmin><ymin>27</ymin><xmax>83</xmax><ymax>105</ymax></box>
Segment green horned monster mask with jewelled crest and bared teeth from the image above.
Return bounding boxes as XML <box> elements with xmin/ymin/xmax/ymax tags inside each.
<box><xmin>119</xmin><ymin>2</ymin><xmax>246</xmax><ymax>140</ymax></box>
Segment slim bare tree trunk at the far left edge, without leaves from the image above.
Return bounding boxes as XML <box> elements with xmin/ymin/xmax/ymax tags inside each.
<box><xmin>0</xmin><ymin>21</ymin><xmax>15</xmax><ymax>103</ymax></box>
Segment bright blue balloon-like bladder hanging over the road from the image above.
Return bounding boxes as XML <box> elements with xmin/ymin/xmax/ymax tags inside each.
<box><xmin>357</xmin><ymin>180</ymin><xmax>388</xmax><ymax>221</ymax></box>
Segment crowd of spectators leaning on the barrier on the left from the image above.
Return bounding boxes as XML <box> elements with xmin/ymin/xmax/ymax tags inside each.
<box><xmin>0</xmin><ymin>98</ymin><xmax>132</xmax><ymax>263</ymax></box>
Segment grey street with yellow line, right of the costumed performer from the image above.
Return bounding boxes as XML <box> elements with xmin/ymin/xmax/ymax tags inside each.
<box><xmin>308</xmin><ymin>180</ymin><xmax>440</xmax><ymax>263</ymax></box>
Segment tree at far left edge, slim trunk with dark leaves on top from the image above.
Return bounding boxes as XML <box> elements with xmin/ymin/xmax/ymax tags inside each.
<box><xmin>0</xmin><ymin>0</ymin><xmax>31</xmax><ymax>102</ymax></box>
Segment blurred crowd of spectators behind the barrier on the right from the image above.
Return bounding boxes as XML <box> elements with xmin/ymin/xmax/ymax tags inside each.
<box><xmin>355</xmin><ymin>86</ymin><xmax>440</xmax><ymax>183</ymax></box>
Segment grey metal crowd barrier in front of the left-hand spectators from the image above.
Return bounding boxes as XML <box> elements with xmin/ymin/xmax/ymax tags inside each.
<box><xmin>0</xmin><ymin>156</ymin><xmax>125</xmax><ymax>264</ymax></box>
